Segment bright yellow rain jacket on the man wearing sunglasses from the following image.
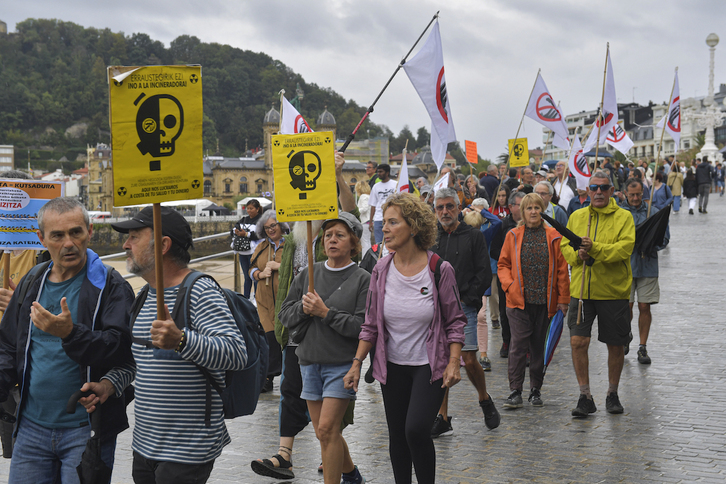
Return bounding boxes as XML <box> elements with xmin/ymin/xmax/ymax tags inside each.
<box><xmin>560</xmin><ymin>198</ymin><xmax>635</xmax><ymax>300</ymax></box>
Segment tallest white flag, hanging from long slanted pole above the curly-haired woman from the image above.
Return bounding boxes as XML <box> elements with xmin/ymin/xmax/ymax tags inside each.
<box><xmin>403</xmin><ymin>21</ymin><xmax>456</xmax><ymax>169</ymax></box>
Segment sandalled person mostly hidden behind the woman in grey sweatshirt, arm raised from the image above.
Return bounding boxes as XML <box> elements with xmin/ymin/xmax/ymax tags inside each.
<box><xmin>251</xmin><ymin>152</ymin><xmax>360</xmax><ymax>479</ymax></box>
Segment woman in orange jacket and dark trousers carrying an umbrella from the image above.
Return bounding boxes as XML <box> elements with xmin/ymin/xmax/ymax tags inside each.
<box><xmin>497</xmin><ymin>193</ymin><xmax>570</xmax><ymax>409</ymax></box>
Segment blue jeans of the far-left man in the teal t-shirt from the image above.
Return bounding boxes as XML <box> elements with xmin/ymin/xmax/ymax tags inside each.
<box><xmin>8</xmin><ymin>418</ymin><xmax>116</xmax><ymax>484</ymax></box>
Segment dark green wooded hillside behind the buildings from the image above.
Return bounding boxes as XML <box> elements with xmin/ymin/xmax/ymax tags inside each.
<box><xmin>0</xmin><ymin>19</ymin><xmax>392</xmax><ymax>168</ymax></box>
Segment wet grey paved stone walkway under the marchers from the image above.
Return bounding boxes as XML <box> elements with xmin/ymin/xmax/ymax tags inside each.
<box><xmin>0</xmin><ymin>194</ymin><xmax>726</xmax><ymax>484</ymax></box>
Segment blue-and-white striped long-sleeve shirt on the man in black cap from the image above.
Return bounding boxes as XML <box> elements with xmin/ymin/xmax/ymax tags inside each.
<box><xmin>104</xmin><ymin>279</ymin><xmax>247</xmax><ymax>464</ymax></box>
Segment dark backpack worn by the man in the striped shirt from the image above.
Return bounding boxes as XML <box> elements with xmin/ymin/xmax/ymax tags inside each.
<box><xmin>131</xmin><ymin>271</ymin><xmax>270</xmax><ymax>427</ymax></box>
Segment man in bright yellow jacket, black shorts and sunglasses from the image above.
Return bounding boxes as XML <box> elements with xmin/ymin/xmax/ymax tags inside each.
<box><xmin>561</xmin><ymin>172</ymin><xmax>635</xmax><ymax>417</ymax></box>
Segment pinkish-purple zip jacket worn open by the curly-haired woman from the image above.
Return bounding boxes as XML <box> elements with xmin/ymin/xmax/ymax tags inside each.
<box><xmin>358</xmin><ymin>251</ymin><xmax>466</xmax><ymax>385</ymax></box>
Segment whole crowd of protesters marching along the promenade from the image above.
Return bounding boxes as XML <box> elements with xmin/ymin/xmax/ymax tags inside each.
<box><xmin>0</xmin><ymin>148</ymin><xmax>712</xmax><ymax>484</ymax></box>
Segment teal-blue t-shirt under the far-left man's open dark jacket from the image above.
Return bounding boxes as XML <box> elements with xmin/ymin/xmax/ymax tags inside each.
<box><xmin>22</xmin><ymin>266</ymin><xmax>88</xmax><ymax>429</ymax></box>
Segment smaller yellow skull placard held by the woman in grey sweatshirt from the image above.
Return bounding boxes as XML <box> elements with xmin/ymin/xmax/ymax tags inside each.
<box><xmin>272</xmin><ymin>131</ymin><xmax>338</xmax><ymax>222</ymax></box>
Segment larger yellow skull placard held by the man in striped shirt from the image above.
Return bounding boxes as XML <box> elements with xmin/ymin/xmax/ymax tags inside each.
<box><xmin>108</xmin><ymin>66</ymin><xmax>204</xmax><ymax>207</ymax></box>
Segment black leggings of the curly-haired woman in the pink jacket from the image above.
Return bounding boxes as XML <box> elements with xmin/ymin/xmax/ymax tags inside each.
<box><xmin>381</xmin><ymin>362</ymin><xmax>445</xmax><ymax>484</ymax></box>
